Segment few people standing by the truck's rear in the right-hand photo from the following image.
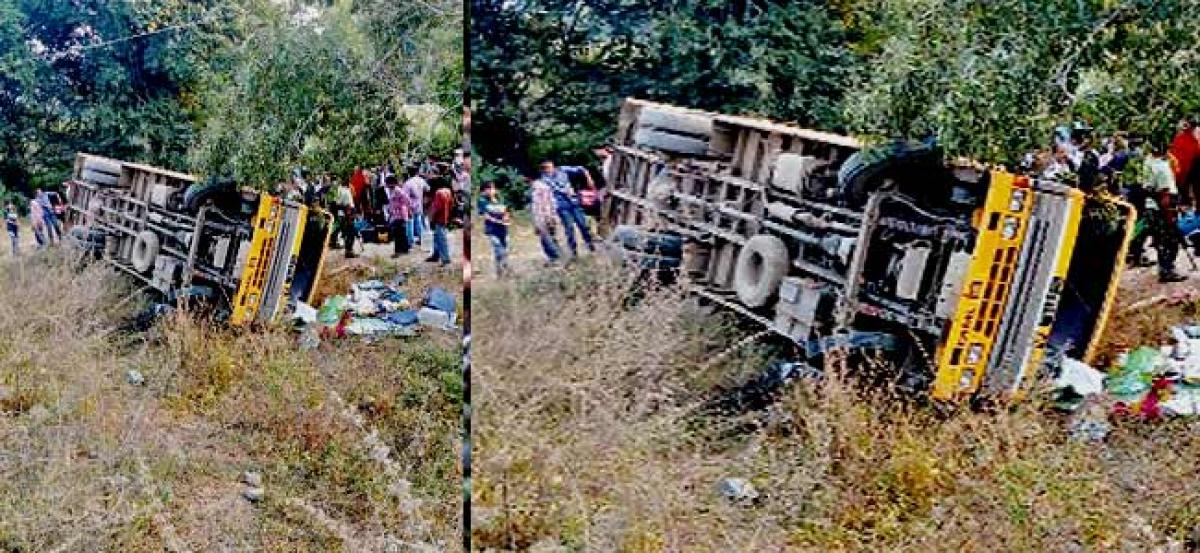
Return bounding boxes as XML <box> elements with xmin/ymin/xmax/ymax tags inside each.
<box><xmin>478</xmin><ymin>146</ymin><xmax>612</xmax><ymax>276</ymax></box>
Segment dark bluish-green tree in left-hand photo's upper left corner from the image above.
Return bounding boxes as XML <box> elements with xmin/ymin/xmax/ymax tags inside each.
<box><xmin>0</xmin><ymin>0</ymin><xmax>228</xmax><ymax>192</ymax></box>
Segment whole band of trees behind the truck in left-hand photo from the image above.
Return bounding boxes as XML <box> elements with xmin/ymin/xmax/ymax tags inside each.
<box><xmin>0</xmin><ymin>0</ymin><xmax>463</xmax><ymax>193</ymax></box>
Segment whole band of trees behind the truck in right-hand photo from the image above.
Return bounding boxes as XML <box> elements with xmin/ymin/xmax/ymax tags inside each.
<box><xmin>470</xmin><ymin>0</ymin><xmax>1200</xmax><ymax>167</ymax></box>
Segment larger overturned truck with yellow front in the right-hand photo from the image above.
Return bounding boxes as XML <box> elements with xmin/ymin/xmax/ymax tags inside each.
<box><xmin>604</xmin><ymin>100</ymin><xmax>1135</xmax><ymax>401</ymax></box>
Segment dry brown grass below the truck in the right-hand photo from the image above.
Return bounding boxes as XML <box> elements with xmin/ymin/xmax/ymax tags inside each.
<box><xmin>473</xmin><ymin>260</ymin><xmax>1200</xmax><ymax>552</ymax></box>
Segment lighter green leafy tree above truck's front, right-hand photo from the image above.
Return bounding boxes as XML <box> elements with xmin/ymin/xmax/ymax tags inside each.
<box><xmin>846</xmin><ymin>0</ymin><xmax>1200</xmax><ymax>162</ymax></box>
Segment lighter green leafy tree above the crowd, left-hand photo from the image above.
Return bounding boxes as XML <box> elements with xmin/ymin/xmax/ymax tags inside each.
<box><xmin>193</xmin><ymin>1</ymin><xmax>462</xmax><ymax>186</ymax></box>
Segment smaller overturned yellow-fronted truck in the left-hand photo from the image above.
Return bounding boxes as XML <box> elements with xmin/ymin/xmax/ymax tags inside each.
<box><xmin>66</xmin><ymin>154</ymin><xmax>332</xmax><ymax>325</ymax></box>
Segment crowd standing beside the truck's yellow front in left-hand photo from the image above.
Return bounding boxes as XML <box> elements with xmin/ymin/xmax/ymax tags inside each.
<box><xmin>276</xmin><ymin>150</ymin><xmax>470</xmax><ymax>266</ymax></box>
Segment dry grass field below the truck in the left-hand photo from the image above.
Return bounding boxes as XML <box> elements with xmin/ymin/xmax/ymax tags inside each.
<box><xmin>0</xmin><ymin>253</ymin><xmax>461</xmax><ymax>552</ymax></box>
